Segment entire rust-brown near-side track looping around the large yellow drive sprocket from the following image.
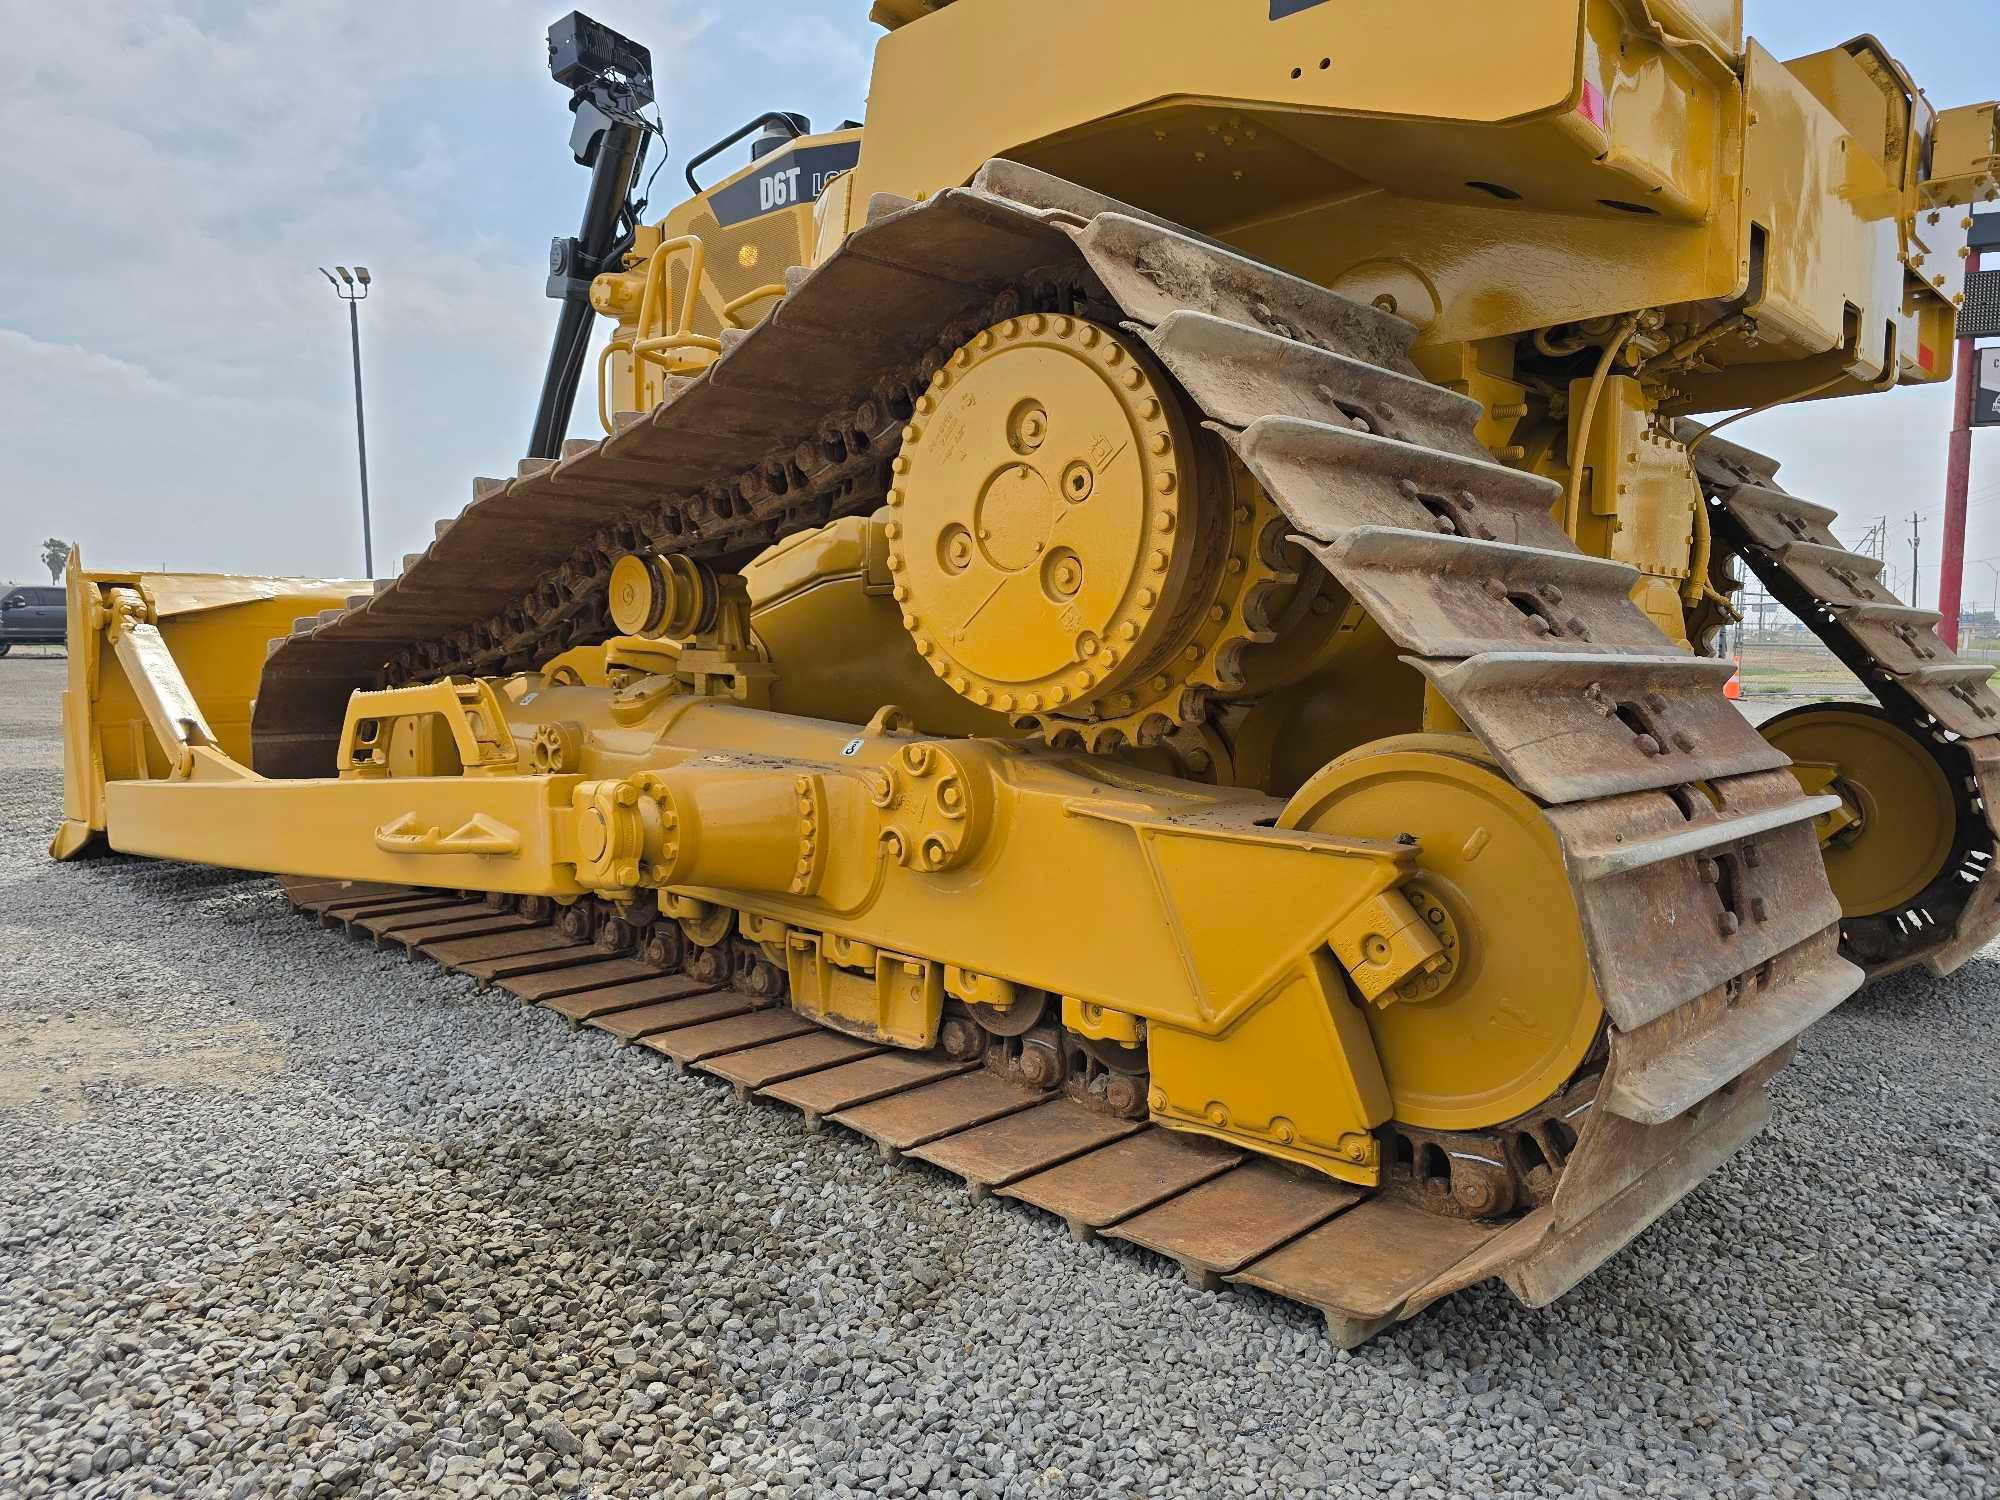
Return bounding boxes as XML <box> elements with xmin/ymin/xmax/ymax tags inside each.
<box><xmin>242</xmin><ymin>162</ymin><xmax>1862</xmax><ymax>1342</ymax></box>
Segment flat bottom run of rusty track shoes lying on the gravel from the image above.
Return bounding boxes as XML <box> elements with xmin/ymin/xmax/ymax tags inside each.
<box><xmin>284</xmin><ymin>878</ymin><xmax>1788</xmax><ymax>1348</ymax></box>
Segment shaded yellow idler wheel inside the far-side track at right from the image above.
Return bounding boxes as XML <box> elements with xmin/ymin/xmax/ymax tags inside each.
<box><xmin>1764</xmin><ymin>704</ymin><xmax>1958</xmax><ymax>918</ymax></box>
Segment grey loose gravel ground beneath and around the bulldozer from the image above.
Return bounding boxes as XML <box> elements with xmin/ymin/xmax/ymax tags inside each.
<box><xmin>0</xmin><ymin>662</ymin><xmax>2000</xmax><ymax>1500</ymax></box>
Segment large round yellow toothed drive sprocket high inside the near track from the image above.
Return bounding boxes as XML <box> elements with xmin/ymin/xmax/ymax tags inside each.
<box><xmin>886</xmin><ymin>314</ymin><xmax>1298</xmax><ymax>752</ymax></box>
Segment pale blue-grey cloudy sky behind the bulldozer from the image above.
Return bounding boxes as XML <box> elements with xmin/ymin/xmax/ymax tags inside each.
<box><xmin>0</xmin><ymin>0</ymin><xmax>2000</xmax><ymax>602</ymax></box>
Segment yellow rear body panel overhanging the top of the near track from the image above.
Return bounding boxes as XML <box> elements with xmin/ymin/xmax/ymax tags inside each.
<box><xmin>856</xmin><ymin>0</ymin><xmax>1994</xmax><ymax>410</ymax></box>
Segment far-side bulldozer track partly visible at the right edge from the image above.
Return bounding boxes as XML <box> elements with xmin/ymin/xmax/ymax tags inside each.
<box><xmin>1696</xmin><ymin>442</ymin><xmax>2000</xmax><ymax>978</ymax></box>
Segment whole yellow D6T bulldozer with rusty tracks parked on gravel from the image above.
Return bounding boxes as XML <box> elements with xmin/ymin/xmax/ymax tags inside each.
<box><xmin>54</xmin><ymin>0</ymin><xmax>2000</xmax><ymax>1344</ymax></box>
